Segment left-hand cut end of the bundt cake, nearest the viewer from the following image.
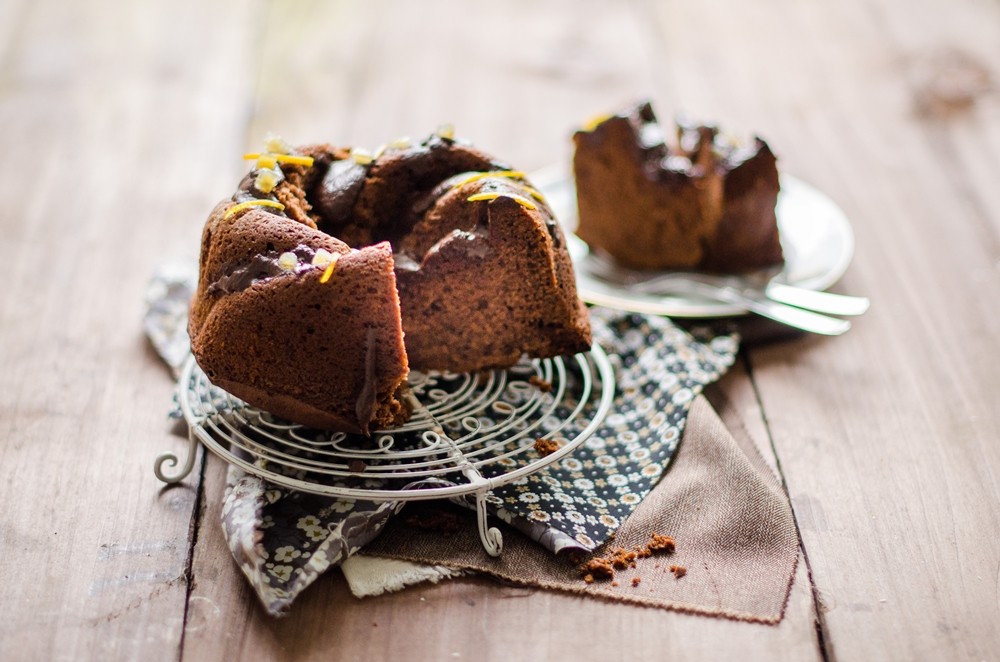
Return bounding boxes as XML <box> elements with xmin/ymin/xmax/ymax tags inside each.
<box><xmin>189</xmin><ymin>208</ymin><xmax>408</xmax><ymax>434</ymax></box>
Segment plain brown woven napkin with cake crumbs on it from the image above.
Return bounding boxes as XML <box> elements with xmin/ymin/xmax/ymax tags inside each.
<box><xmin>364</xmin><ymin>397</ymin><xmax>798</xmax><ymax>623</ymax></box>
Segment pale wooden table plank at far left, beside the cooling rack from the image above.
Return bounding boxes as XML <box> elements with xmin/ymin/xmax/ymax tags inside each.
<box><xmin>0</xmin><ymin>0</ymin><xmax>262</xmax><ymax>660</ymax></box>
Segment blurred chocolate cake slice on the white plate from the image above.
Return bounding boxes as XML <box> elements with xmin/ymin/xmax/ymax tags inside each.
<box><xmin>573</xmin><ymin>102</ymin><xmax>783</xmax><ymax>273</ymax></box>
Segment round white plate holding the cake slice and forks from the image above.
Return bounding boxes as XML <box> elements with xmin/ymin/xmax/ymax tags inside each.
<box><xmin>530</xmin><ymin>165</ymin><xmax>854</xmax><ymax>317</ymax></box>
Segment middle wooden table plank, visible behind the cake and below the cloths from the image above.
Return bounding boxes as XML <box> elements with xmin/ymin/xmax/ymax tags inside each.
<box><xmin>184</xmin><ymin>1</ymin><xmax>819</xmax><ymax>659</ymax></box>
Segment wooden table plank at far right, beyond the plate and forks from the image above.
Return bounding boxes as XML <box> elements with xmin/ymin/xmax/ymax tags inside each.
<box><xmin>640</xmin><ymin>0</ymin><xmax>1000</xmax><ymax>659</ymax></box>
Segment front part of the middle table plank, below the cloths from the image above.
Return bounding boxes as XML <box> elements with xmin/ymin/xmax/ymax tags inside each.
<box><xmin>183</xmin><ymin>422</ymin><xmax>819</xmax><ymax>660</ymax></box>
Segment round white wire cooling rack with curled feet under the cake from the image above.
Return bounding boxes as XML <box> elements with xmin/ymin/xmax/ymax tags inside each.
<box><xmin>154</xmin><ymin>344</ymin><xmax>615</xmax><ymax>556</ymax></box>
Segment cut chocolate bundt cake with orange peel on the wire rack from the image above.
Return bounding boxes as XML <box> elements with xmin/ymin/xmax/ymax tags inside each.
<box><xmin>189</xmin><ymin>131</ymin><xmax>591</xmax><ymax>434</ymax></box>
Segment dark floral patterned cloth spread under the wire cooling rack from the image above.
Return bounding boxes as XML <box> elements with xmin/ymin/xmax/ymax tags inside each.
<box><xmin>146</xmin><ymin>268</ymin><xmax>738</xmax><ymax>615</ymax></box>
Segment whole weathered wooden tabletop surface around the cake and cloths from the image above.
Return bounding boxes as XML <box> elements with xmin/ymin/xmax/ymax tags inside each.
<box><xmin>0</xmin><ymin>0</ymin><xmax>1000</xmax><ymax>662</ymax></box>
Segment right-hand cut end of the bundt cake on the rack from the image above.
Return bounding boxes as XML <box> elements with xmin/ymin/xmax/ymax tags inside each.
<box><xmin>396</xmin><ymin>171</ymin><xmax>590</xmax><ymax>372</ymax></box>
